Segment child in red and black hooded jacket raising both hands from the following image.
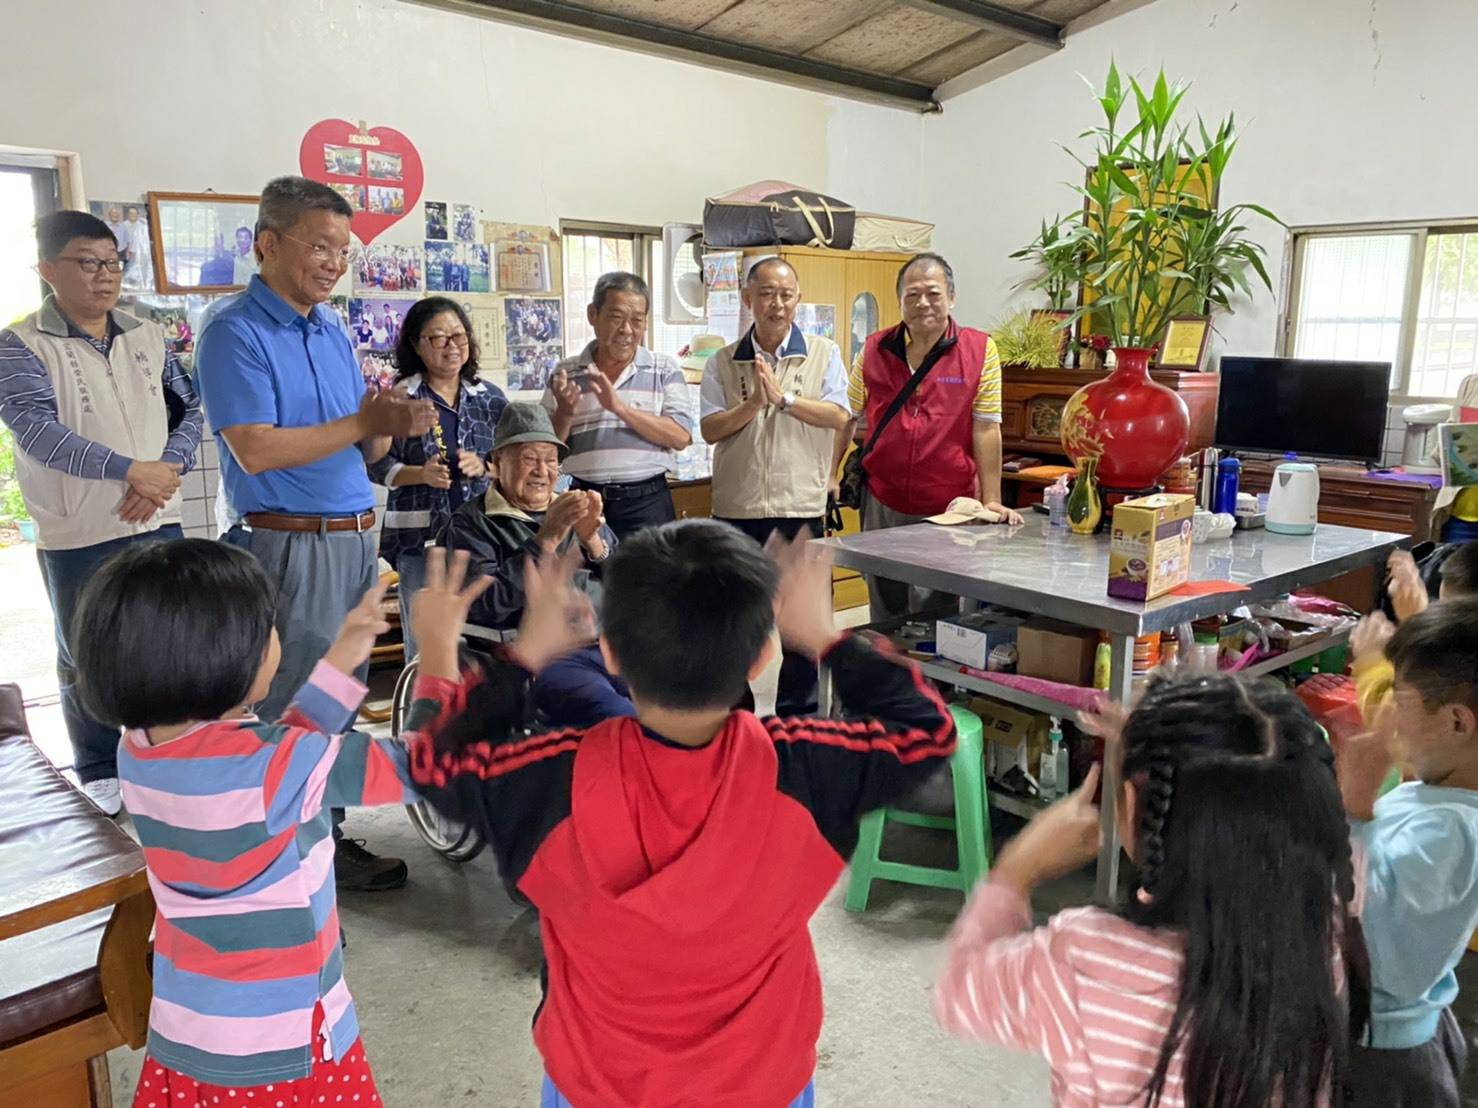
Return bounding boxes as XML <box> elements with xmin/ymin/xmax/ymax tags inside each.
<box><xmin>408</xmin><ymin>520</ymin><xmax>955</xmax><ymax>1108</ymax></box>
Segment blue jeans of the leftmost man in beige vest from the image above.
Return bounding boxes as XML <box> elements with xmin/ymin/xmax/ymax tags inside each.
<box><xmin>35</xmin><ymin>523</ymin><xmax>185</xmax><ymax>784</ymax></box>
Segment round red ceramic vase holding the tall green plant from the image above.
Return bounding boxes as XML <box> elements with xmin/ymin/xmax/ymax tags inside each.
<box><xmin>1063</xmin><ymin>347</ymin><xmax>1191</xmax><ymax>490</ymax></box>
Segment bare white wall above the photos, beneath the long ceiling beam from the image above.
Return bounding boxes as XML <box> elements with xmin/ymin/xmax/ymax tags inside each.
<box><xmin>0</xmin><ymin>0</ymin><xmax>922</xmax><ymax>242</ymax></box>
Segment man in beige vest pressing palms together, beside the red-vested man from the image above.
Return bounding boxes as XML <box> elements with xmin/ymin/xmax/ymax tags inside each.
<box><xmin>699</xmin><ymin>257</ymin><xmax>850</xmax><ymax>715</ymax></box>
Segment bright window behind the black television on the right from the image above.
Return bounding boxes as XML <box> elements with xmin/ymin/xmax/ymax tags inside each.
<box><xmin>1284</xmin><ymin>225</ymin><xmax>1478</xmax><ymax>400</ymax></box>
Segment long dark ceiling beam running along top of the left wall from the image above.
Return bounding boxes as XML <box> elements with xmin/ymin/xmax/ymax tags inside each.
<box><xmin>421</xmin><ymin>0</ymin><xmax>940</xmax><ymax>112</ymax></box>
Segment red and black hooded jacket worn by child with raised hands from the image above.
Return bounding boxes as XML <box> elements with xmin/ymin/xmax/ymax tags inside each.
<box><xmin>408</xmin><ymin>635</ymin><xmax>955</xmax><ymax>1108</ymax></box>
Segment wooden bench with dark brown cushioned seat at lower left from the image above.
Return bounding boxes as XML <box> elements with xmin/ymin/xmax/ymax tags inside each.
<box><xmin>0</xmin><ymin>685</ymin><xmax>154</xmax><ymax>1108</ymax></box>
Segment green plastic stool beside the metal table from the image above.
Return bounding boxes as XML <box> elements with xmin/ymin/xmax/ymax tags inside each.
<box><xmin>847</xmin><ymin>706</ymin><xmax>990</xmax><ymax>912</ymax></box>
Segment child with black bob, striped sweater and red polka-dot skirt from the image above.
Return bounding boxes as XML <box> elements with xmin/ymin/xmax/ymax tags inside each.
<box><xmin>77</xmin><ymin>539</ymin><xmax>434</xmax><ymax>1108</ymax></box>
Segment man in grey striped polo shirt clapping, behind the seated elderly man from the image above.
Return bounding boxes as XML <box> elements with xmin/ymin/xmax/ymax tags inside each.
<box><xmin>542</xmin><ymin>273</ymin><xmax>693</xmax><ymax>539</ymax></box>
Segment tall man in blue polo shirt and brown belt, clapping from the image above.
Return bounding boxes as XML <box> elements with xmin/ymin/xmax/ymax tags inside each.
<box><xmin>195</xmin><ymin>177</ymin><xmax>436</xmax><ymax>889</ymax></box>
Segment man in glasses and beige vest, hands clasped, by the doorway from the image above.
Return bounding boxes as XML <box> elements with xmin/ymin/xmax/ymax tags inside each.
<box><xmin>0</xmin><ymin>211</ymin><xmax>201</xmax><ymax>815</ymax></box>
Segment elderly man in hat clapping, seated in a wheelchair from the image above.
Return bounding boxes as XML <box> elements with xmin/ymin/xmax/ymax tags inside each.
<box><xmin>393</xmin><ymin>403</ymin><xmax>636</xmax><ymax>861</ymax></box>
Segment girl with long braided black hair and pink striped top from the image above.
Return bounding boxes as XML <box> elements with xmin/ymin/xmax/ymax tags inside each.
<box><xmin>936</xmin><ymin>675</ymin><xmax>1369</xmax><ymax>1108</ymax></box>
